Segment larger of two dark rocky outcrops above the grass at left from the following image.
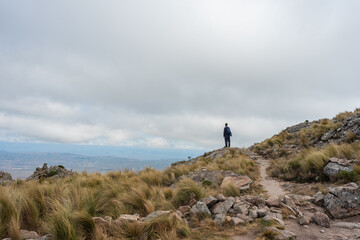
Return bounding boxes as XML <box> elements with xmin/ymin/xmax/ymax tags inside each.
<box><xmin>26</xmin><ymin>163</ymin><xmax>74</xmax><ymax>180</ymax></box>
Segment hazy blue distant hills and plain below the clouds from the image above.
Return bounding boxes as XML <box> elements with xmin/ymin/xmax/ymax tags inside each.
<box><xmin>0</xmin><ymin>151</ymin><xmax>181</xmax><ymax>179</ymax></box>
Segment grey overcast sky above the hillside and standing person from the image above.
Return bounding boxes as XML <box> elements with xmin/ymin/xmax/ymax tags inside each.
<box><xmin>0</xmin><ymin>0</ymin><xmax>360</xmax><ymax>148</ymax></box>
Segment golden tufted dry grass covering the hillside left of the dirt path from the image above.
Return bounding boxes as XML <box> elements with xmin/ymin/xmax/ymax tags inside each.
<box><xmin>0</xmin><ymin>149</ymin><xmax>258</xmax><ymax>240</ymax></box>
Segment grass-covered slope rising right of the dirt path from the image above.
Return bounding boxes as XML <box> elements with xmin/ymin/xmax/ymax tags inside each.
<box><xmin>253</xmin><ymin>109</ymin><xmax>360</xmax><ymax>182</ymax></box>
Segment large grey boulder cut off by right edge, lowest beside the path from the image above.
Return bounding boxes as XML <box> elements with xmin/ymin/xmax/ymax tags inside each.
<box><xmin>324</xmin><ymin>183</ymin><xmax>360</xmax><ymax>218</ymax></box>
